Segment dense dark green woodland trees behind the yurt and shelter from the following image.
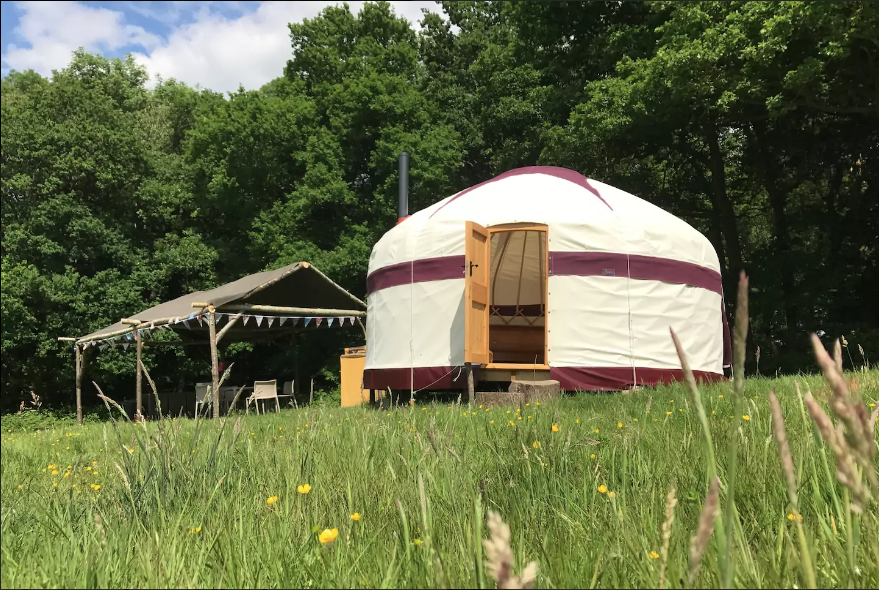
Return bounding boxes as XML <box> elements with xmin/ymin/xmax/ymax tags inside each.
<box><xmin>0</xmin><ymin>2</ymin><xmax>879</xmax><ymax>407</ymax></box>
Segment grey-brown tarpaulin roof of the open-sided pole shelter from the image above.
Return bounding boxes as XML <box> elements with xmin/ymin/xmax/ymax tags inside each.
<box><xmin>78</xmin><ymin>262</ymin><xmax>366</xmax><ymax>342</ymax></box>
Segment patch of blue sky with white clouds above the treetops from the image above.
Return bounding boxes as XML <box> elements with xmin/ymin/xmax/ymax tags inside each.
<box><xmin>0</xmin><ymin>1</ymin><xmax>441</xmax><ymax>92</ymax></box>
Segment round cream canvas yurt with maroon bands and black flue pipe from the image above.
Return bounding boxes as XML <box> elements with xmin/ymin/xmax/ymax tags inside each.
<box><xmin>364</xmin><ymin>166</ymin><xmax>729</xmax><ymax>391</ymax></box>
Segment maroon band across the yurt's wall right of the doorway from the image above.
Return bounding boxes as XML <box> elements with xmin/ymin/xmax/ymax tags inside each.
<box><xmin>549</xmin><ymin>252</ymin><xmax>723</xmax><ymax>295</ymax></box>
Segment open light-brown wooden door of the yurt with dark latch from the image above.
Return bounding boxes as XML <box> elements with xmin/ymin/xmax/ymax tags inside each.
<box><xmin>464</xmin><ymin>221</ymin><xmax>491</xmax><ymax>365</ymax></box>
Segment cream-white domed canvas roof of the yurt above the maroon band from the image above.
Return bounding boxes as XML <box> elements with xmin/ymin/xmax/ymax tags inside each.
<box><xmin>369</xmin><ymin>166</ymin><xmax>720</xmax><ymax>272</ymax></box>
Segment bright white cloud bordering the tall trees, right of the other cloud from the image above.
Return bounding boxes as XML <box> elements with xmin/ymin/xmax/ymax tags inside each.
<box><xmin>135</xmin><ymin>2</ymin><xmax>437</xmax><ymax>91</ymax></box>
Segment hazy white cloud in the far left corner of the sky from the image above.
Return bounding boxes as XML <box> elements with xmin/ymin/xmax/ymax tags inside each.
<box><xmin>3</xmin><ymin>2</ymin><xmax>162</xmax><ymax>75</ymax></box>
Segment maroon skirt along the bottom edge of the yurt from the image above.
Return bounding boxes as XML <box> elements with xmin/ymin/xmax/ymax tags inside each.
<box><xmin>363</xmin><ymin>366</ymin><xmax>724</xmax><ymax>391</ymax></box>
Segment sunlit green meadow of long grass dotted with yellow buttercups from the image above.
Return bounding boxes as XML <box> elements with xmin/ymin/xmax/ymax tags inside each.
<box><xmin>0</xmin><ymin>371</ymin><xmax>879</xmax><ymax>588</ymax></box>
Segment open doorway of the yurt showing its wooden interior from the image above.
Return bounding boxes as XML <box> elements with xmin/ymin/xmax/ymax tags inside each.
<box><xmin>487</xmin><ymin>224</ymin><xmax>548</xmax><ymax>368</ymax></box>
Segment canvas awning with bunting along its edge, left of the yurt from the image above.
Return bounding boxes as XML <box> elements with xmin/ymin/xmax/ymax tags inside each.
<box><xmin>76</xmin><ymin>262</ymin><xmax>366</xmax><ymax>346</ymax></box>
